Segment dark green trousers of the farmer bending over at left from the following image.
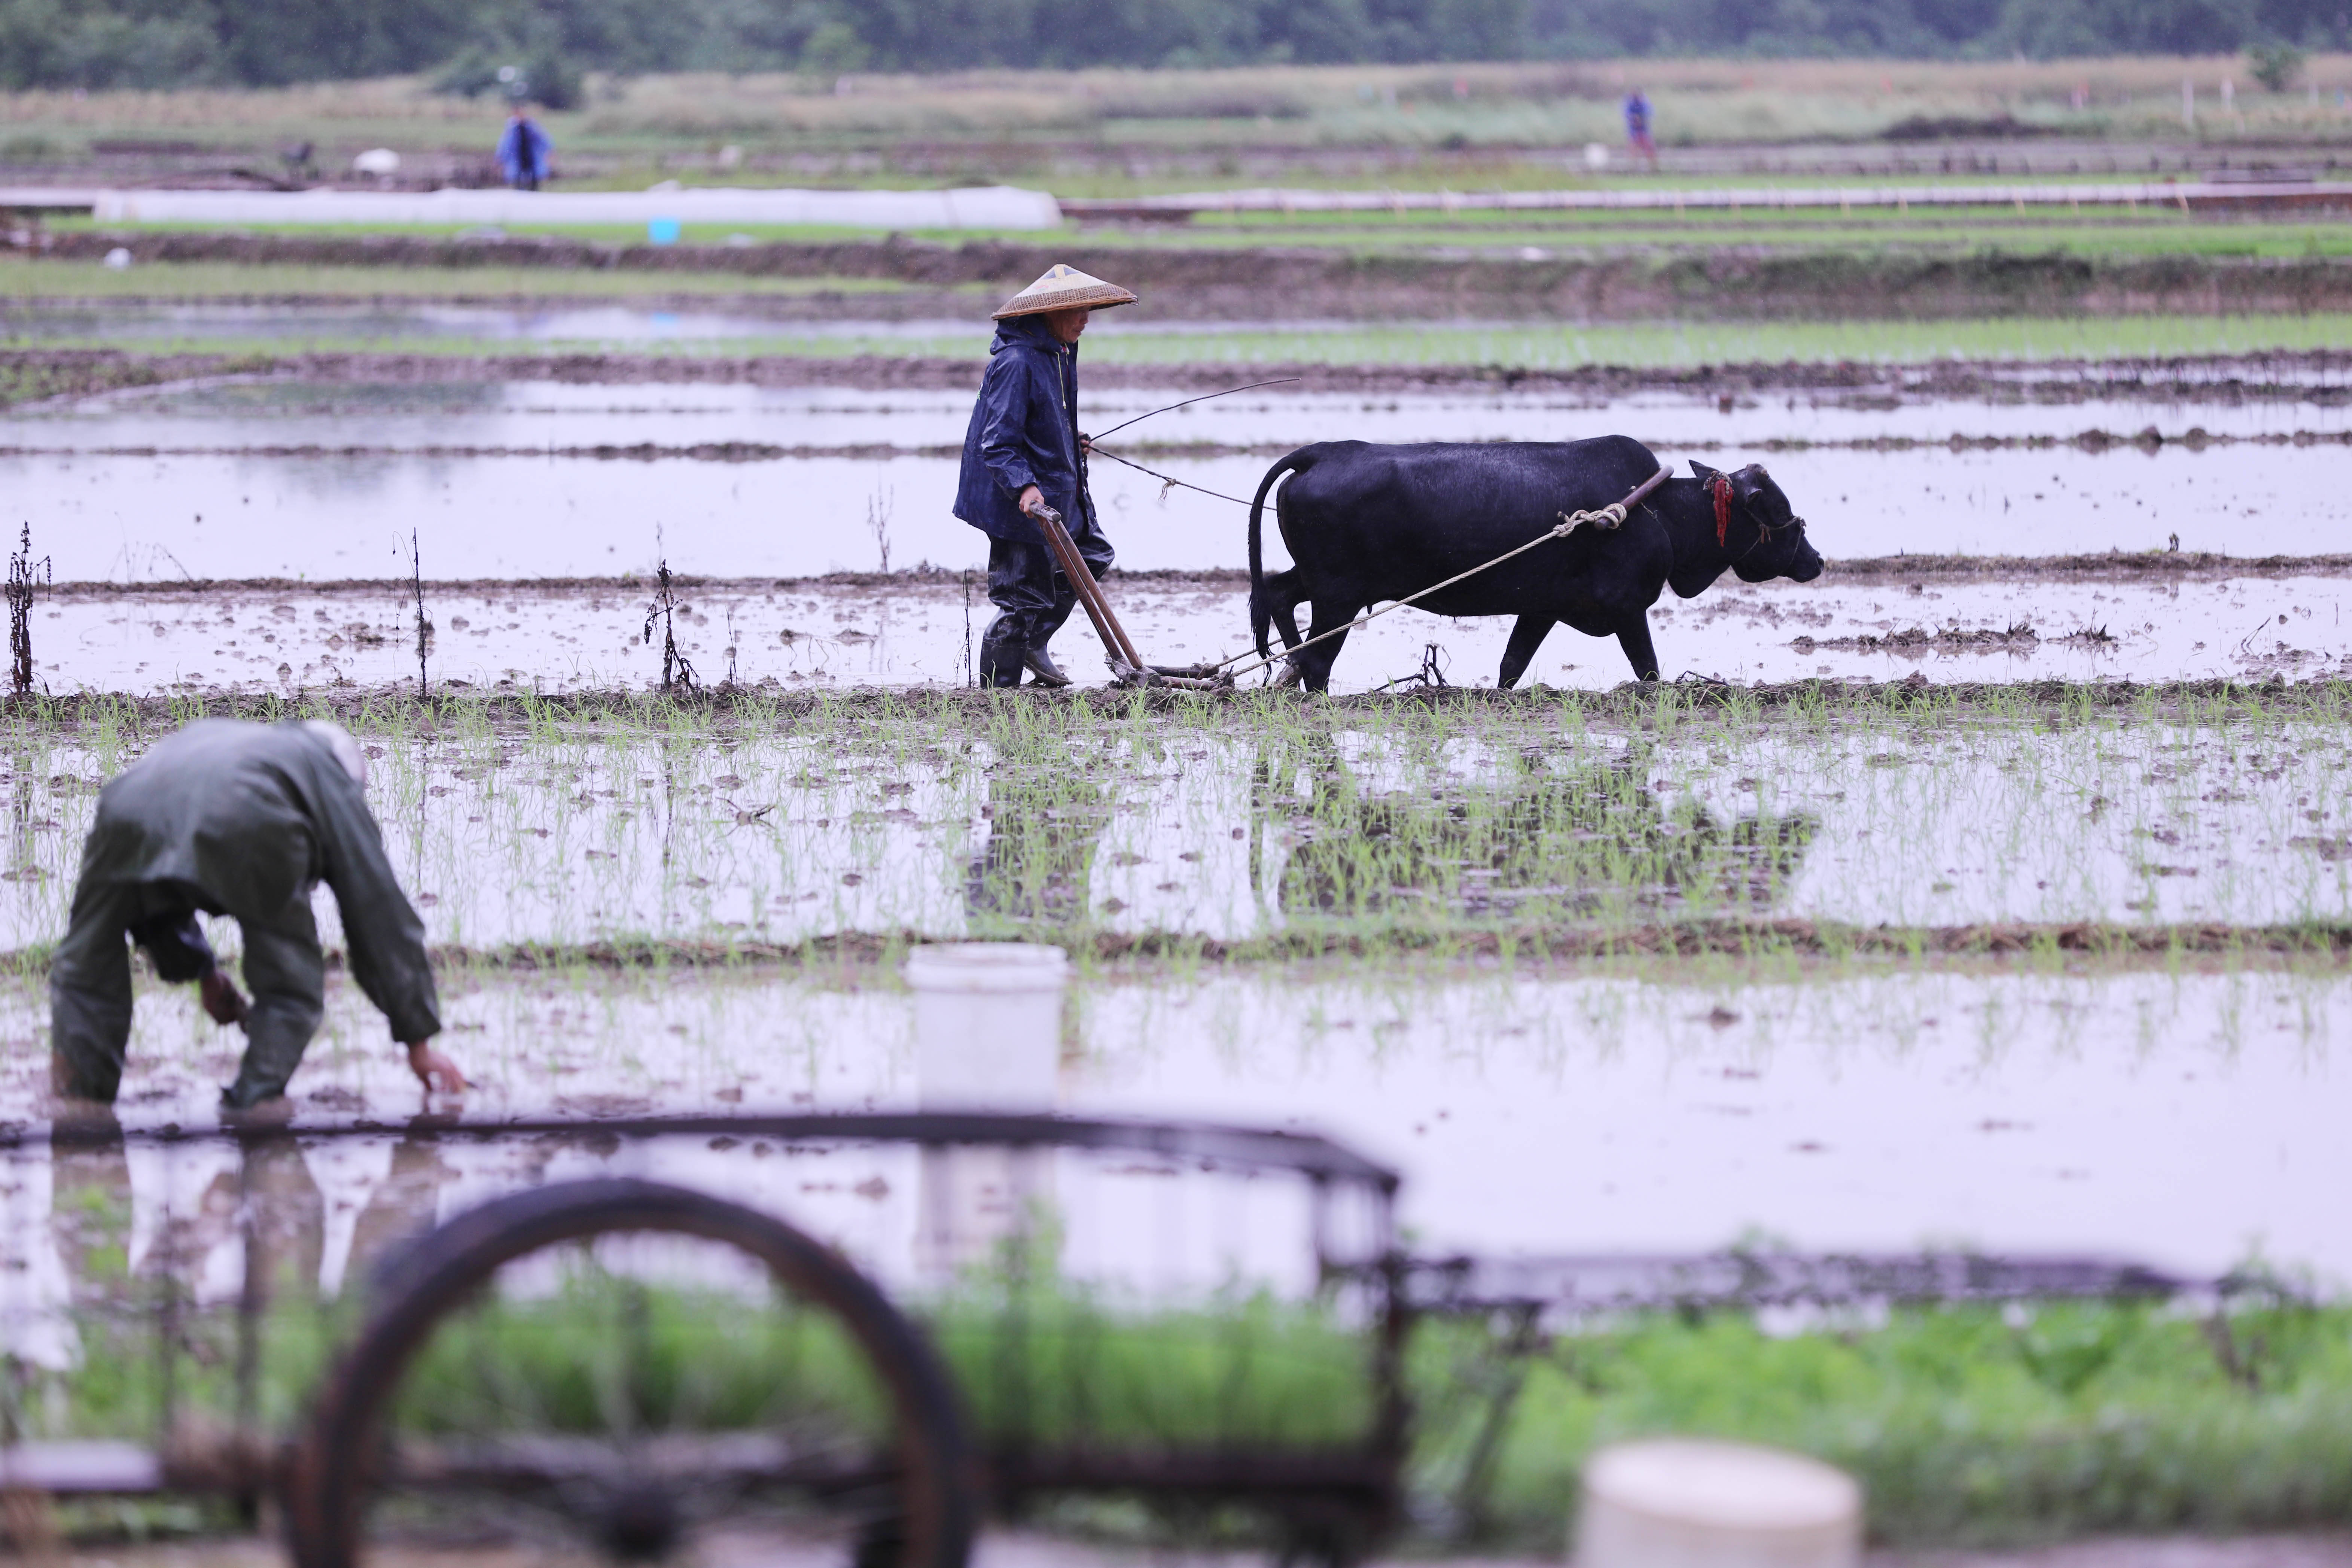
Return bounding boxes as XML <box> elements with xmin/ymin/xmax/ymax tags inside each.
<box><xmin>49</xmin><ymin>882</ymin><xmax>327</xmax><ymax>1109</ymax></box>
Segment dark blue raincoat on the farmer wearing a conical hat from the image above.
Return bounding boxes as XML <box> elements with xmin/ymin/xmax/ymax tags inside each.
<box><xmin>955</xmin><ymin>315</ymin><xmax>1094</xmax><ymax>548</ymax></box>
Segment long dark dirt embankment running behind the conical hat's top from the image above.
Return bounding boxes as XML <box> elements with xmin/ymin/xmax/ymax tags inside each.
<box><xmin>27</xmin><ymin>233</ymin><xmax>2352</xmax><ymax>322</ymax></box>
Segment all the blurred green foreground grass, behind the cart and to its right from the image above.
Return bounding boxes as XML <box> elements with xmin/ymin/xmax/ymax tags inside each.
<box><xmin>16</xmin><ymin>1281</ymin><xmax>2352</xmax><ymax>1552</ymax></box>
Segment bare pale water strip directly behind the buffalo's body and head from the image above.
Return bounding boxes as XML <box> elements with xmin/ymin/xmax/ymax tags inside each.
<box><xmin>0</xmin><ymin>447</ymin><xmax>2352</xmax><ymax>583</ymax></box>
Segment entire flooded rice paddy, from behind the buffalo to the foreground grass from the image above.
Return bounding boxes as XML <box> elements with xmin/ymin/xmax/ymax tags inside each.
<box><xmin>0</xmin><ymin>341</ymin><xmax>2352</xmax><ymax>1335</ymax></box>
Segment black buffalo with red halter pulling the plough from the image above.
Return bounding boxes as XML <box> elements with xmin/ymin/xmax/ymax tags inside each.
<box><xmin>1249</xmin><ymin>435</ymin><xmax>1821</xmax><ymax>691</ymax></box>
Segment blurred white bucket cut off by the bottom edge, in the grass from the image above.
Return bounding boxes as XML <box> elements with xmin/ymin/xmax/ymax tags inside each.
<box><xmin>1576</xmin><ymin>1439</ymin><xmax>1863</xmax><ymax>1568</ymax></box>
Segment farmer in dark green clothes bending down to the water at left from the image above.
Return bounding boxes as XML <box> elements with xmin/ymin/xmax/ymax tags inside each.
<box><xmin>49</xmin><ymin>719</ymin><xmax>466</xmax><ymax>1109</ymax></box>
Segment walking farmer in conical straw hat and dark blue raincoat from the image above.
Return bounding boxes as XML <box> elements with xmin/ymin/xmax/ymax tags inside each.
<box><xmin>955</xmin><ymin>266</ymin><xmax>1136</xmax><ymax>686</ymax></box>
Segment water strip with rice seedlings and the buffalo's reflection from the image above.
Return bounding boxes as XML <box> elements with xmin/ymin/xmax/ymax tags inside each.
<box><xmin>0</xmin><ymin>712</ymin><xmax>2352</xmax><ymax>950</ymax></box>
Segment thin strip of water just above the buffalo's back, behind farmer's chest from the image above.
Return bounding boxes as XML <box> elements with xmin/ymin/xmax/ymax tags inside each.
<box><xmin>23</xmin><ymin>376</ymin><xmax>2352</xmax><ymax>449</ymax></box>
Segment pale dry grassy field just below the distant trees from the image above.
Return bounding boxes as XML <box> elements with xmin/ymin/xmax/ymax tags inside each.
<box><xmin>5</xmin><ymin>54</ymin><xmax>2352</xmax><ymax>183</ymax></box>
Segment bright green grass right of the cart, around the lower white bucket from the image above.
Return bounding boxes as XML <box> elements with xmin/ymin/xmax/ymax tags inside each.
<box><xmin>1458</xmin><ymin>1305</ymin><xmax>2352</xmax><ymax>1547</ymax></box>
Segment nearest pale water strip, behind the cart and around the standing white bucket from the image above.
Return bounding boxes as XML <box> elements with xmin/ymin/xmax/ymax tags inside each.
<box><xmin>0</xmin><ymin>971</ymin><xmax>2352</xmax><ymax>1281</ymax></box>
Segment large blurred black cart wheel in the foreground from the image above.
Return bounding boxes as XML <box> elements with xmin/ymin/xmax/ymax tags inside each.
<box><xmin>284</xmin><ymin>1180</ymin><xmax>978</xmax><ymax>1568</ymax></box>
